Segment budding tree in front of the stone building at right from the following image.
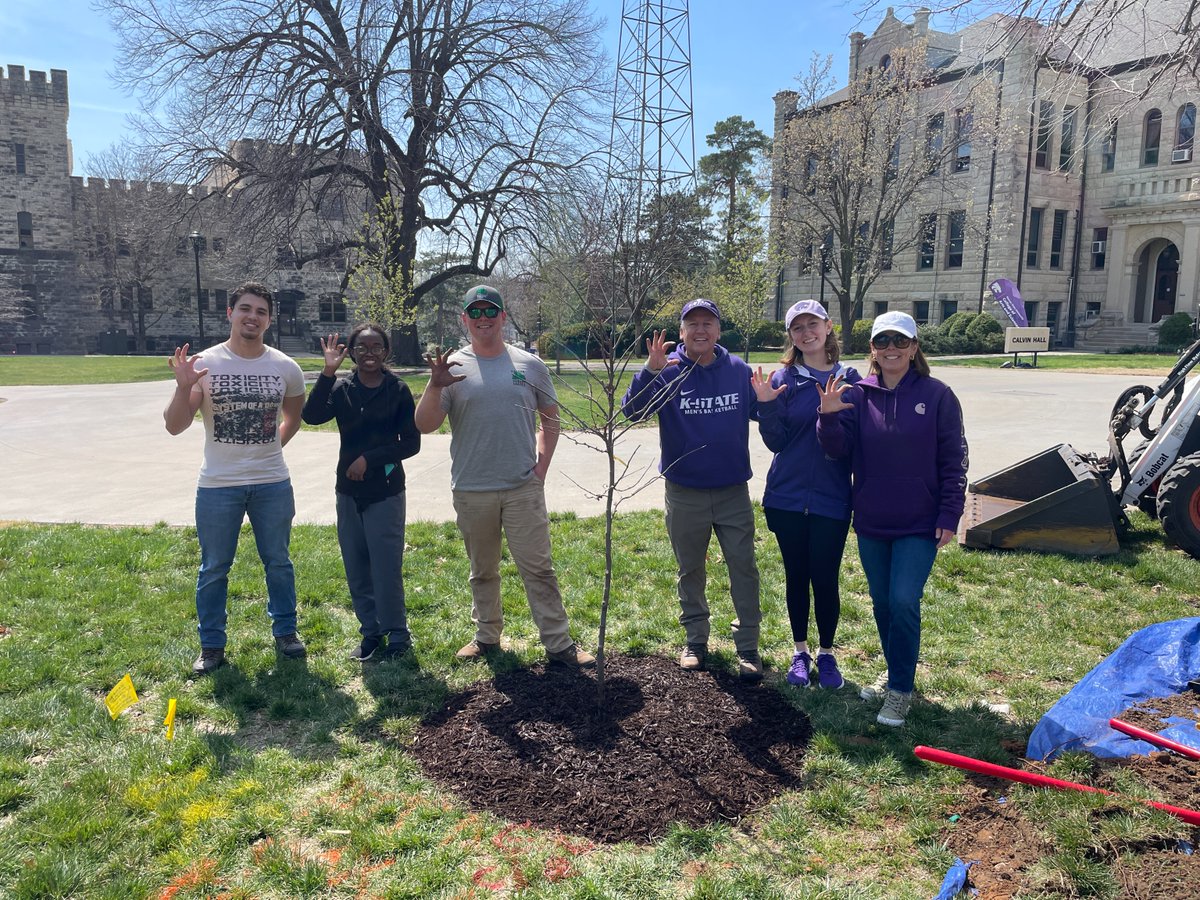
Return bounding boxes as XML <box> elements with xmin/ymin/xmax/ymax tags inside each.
<box><xmin>772</xmin><ymin>48</ymin><xmax>1002</xmax><ymax>341</ymax></box>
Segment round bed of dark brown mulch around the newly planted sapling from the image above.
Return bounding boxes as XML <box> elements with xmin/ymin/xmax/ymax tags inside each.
<box><xmin>413</xmin><ymin>654</ymin><xmax>811</xmax><ymax>842</ymax></box>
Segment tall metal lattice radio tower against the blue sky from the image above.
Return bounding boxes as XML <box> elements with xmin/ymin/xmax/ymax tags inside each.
<box><xmin>610</xmin><ymin>0</ymin><xmax>696</xmax><ymax>199</ymax></box>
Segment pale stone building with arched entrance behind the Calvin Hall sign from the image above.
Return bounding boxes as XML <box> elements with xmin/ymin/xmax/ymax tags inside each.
<box><xmin>772</xmin><ymin>0</ymin><xmax>1200</xmax><ymax>348</ymax></box>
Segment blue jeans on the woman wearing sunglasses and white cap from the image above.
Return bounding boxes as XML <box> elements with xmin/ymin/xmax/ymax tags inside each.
<box><xmin>858</xmin><ymin>535</ymin><xmax>937</xmax><ymax>694</ymax></box>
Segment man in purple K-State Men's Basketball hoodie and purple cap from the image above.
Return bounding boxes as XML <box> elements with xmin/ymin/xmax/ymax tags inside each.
<box><xmin>622</xmin><ymin>300</ymin><xmax>762</xmax><ymax>682</ymax></box>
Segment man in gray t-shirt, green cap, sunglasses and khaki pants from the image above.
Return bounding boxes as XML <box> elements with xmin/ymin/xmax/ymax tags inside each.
<box><xmin>415</xmin><ymin>284</ymin><xmax>595</xmax><ymax>667</ymax></box>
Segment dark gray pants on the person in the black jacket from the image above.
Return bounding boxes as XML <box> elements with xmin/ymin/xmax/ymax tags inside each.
<box><xmin>337</xmin><ymin>491</ymin><xmax>413</xmax><ymax>646</ymax></box>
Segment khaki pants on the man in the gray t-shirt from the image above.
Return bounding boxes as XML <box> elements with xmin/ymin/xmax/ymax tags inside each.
<box><xmin>454</xmin><ymin>478</ymin><xmax>571</xmax><ymax>653</ymax></box>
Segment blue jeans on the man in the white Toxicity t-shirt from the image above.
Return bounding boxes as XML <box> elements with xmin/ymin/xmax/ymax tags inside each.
<box><xmin>196</xmin><ymin>480</ymin><xmax>296</xmax><ymax>648</ymax></box>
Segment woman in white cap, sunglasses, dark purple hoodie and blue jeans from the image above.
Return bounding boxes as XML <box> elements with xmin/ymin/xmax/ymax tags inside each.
<box><xmin>817</xmin><ymin>312</ymin><xmax>967</xmax><ymax>727</ymax></box>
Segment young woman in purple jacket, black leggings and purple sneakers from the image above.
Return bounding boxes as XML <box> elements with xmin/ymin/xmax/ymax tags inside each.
<box><xmin>750</xmin><ymin>300</ymin><xmax>862</xmax><ymax>690</ymax></box>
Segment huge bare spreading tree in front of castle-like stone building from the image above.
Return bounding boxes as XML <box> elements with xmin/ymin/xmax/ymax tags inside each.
<box><xmin>102</xmin><ymin>0</ymin><xmax>606</xmax><ymax>361</ymax></box>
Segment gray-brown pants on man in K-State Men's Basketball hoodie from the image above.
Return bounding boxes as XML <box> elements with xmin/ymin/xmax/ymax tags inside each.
<box><xmin>666</xmin><ymin>481</ymin><xmax>762</xmax><ymax>656</ymax></box>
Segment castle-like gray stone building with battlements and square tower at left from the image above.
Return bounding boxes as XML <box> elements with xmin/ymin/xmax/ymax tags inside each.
<box><xmin>0</xmin><ymin>60</ymin><xmax>364</xmax><ymax>353</ymax></box>
